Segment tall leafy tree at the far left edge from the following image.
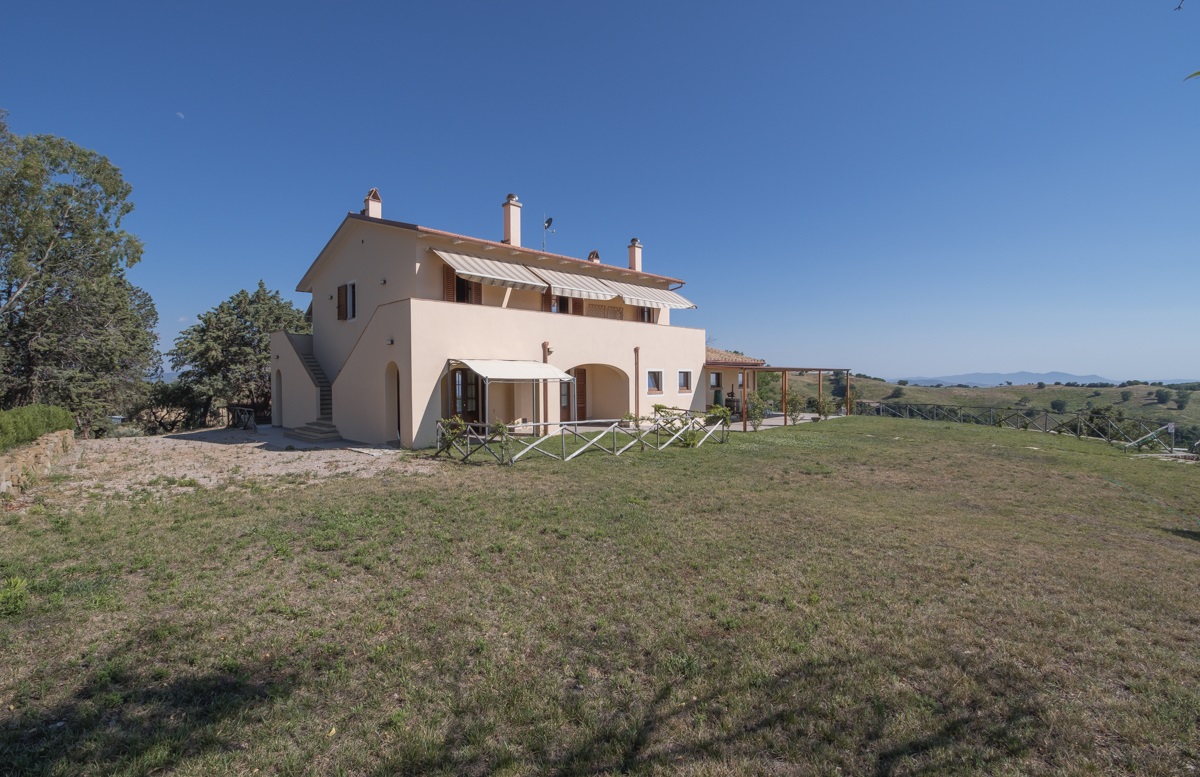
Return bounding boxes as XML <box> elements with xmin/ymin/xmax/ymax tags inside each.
<box><xmin>0</xmin><ymin>113</ymin><xmax>161</xmax><ymax>435</ymax></box>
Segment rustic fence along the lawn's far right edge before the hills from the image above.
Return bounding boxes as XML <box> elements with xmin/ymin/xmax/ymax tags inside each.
<box><xmin>854</xmin><ymin>400</ymin><xmax>1171</xmax><ymax>453</ymax></box>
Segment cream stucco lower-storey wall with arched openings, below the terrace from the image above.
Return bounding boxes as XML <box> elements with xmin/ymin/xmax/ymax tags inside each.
<box><xmin>334</xmin><ymin>294</ymin><xmax>704</xmax><ymax>447</ymax></box>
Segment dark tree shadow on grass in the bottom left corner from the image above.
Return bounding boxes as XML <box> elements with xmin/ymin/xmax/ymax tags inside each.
<box><xmin>0</xmin><ymin>658</ymin><xmax>296</xmax><ymax>775</ymax></box>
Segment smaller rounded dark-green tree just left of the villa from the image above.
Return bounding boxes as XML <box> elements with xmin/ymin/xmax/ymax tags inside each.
<box><xmin>168</xmin><ymin>281</ymin><xmax>311</xmax><ymax>418</ymax></box>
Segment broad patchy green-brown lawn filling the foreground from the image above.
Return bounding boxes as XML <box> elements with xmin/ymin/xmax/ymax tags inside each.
<box><xmin>0</xmin><ymin>417</ymin><xmax>1200</xmax><ymax>775</ymax></box>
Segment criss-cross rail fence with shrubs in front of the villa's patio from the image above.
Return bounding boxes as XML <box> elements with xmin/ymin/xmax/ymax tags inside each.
<box><xmin>434</xmin><ymin>410</ymin><xmax>730</xmax><ymax>464</ymax></box>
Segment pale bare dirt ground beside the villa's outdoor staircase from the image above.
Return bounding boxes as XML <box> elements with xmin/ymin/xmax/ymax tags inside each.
<box><xmin>5</xmin><ymin>429</ymin><xmax>439</xmax><ymax>511</ymax></box>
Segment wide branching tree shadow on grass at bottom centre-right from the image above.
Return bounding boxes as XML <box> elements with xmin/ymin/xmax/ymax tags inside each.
<box><xmin>374</xmin><ymin>652</ymin><xmax>1045</xmax><ymax>777</ymax></box>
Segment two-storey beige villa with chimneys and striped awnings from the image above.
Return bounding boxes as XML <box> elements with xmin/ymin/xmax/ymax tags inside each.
<box><xmin>271</xmin><ymin>189</ymin><xmax>736</xmax><ymax>447</ymax></box>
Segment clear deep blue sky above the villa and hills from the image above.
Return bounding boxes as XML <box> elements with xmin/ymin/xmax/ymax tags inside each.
<box><xmin>0</xmin><ymin>0</ymin><xmax>1200</xmax><ymax>379</ymax></box>
